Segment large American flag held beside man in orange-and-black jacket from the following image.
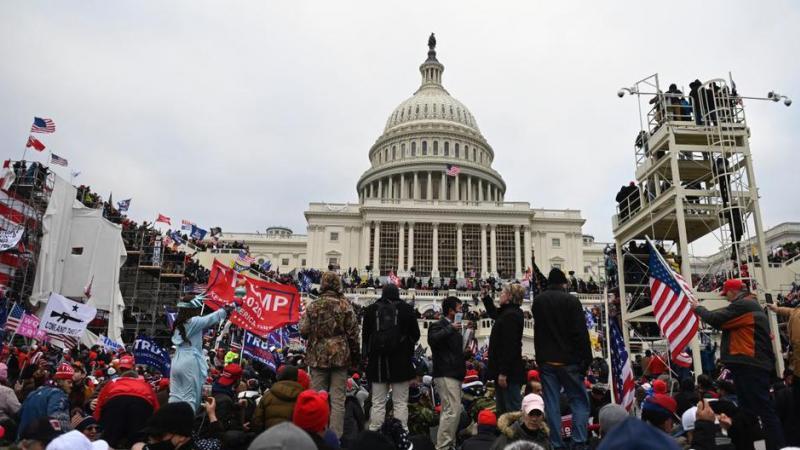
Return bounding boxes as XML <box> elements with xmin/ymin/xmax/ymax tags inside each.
<box><xmin>648</xmin><ymin>240</ymin><xmax>699</xmax><ymax>360</ymax></box>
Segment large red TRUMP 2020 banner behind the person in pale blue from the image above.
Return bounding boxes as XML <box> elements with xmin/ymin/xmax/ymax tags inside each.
<box><xmin>205</xmin><ymin>259</ymin><xmax>301</xmax><ymax>337</ymax></box>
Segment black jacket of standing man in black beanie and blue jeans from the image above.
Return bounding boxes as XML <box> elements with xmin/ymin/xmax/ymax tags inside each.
<box><xmin>531</xmin><ymin>289</ymin><xmax>592</xmax><ymax>368</ymax></box>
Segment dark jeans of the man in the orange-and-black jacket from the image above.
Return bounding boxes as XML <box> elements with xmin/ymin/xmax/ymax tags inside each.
<box><xmin>728</xmin><ymin>364</ymin><xmax>785</xmax><ymax>450</ymax></box>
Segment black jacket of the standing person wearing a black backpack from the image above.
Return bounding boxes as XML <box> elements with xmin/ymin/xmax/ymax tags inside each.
<box><xmin>361</xmin><ymin>300</ymin><xmax>419</xmax><ymax>383</ymax></box>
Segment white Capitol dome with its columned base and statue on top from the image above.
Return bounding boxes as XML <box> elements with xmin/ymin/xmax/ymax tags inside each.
<box><xmin>357</xmin><ymin>34</ymin><xmax>506</xmax><ymax>203</ymax></box>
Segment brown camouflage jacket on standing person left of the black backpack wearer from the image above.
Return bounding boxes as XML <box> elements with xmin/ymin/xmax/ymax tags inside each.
<box><xmin>300</xmin><ymin>292</ymin><xmax>361</xmax><ymax>369</ymax></box>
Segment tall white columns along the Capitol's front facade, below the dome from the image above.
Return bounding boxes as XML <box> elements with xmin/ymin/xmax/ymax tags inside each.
<box><xmin>362</xmin><ymin>221</ymin><xmax>532</xmax><ymax>279</ymax></box>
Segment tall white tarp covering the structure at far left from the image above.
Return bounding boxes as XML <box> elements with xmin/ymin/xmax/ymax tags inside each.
<box><xmin>31</xmin><ymin>176</ymin><xmax>127</xmax><ymax>342</ymax></box>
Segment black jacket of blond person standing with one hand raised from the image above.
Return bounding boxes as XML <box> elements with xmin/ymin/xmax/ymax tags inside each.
<box><xmin>483</xmin><ymin>295</ymin><xmax>525</xmax><ymax>383</ymax></box>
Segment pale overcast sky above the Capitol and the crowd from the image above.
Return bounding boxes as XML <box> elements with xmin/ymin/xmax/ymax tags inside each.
<box><xmin>0</xmin><ymin>0</ymin><xmax>800</xmax><ymax>255</ymax></box>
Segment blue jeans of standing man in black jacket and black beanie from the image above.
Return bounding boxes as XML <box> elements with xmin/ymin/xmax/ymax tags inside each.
<box><xmin>539</xmin><ymin>364</ymin><xmax>589</xmax><ymax>449</ymax></box>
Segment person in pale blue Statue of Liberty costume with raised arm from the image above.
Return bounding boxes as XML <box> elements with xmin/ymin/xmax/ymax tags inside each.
<box><xmin>169</xmin><ymin>295</ymin><xmax>235</xmax><ymax>411</ymax></box>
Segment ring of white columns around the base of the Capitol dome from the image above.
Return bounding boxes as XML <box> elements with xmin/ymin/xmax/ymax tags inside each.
<box><xmin>359</xmin><ymin>171</ymin><xmax>504</xmax><ymax>202</ymax></box>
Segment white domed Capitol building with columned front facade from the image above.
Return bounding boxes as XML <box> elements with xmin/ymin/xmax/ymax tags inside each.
<box><xmin>223</xmin><ymin>35</ymin><xmax>604</xmax><ymax>280</ymax></box>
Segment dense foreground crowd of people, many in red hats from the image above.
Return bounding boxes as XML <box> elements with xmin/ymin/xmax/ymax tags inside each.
<box><xmin>0</xmin><ymin>269</ymin><xmax>800</xmax><ymax>450</ymax></box>
